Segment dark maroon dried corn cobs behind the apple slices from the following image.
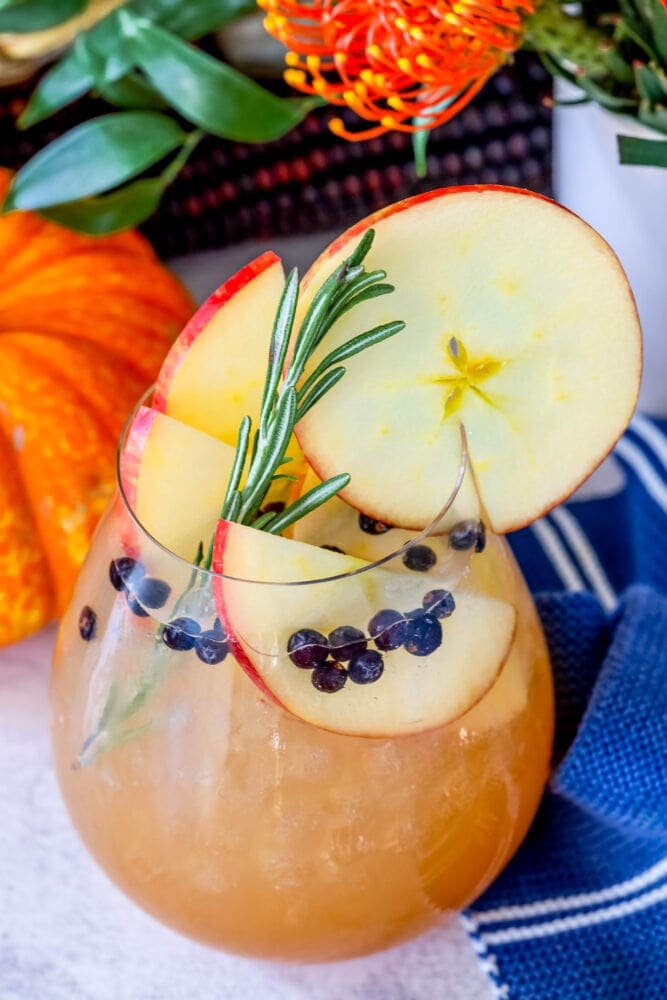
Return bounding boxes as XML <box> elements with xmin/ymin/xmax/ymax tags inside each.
<box><xmin>0</xmin><ymin>53</ymin><xmax>551</xmax><ymax>257</ymax></box>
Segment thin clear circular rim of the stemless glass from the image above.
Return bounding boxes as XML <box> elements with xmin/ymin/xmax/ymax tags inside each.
<box><xmin>116</xmin><ymin>384</ymin><xmax>472</xmax><ymax>587</ymax></box>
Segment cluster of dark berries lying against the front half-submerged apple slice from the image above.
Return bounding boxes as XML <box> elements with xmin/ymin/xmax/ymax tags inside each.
<box><xmin>287</xmin><ymin>590</ymin><xmax>455</xmax><ymax>694</ymax></box>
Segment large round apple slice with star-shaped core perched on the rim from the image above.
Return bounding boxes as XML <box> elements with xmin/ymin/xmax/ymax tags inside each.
<box><xmin>297</xmin><ymin>187</ymin><xmax>641</xmax><ymax>532</ymax></box>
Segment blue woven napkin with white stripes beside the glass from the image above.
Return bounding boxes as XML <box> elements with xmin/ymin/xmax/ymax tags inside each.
<box><xmin>462</xmin><ymin>416</ymin><xmax>667</xmax><ymax>1000</ymax></box>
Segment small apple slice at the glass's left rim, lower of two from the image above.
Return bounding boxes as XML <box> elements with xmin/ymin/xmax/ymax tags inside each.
<box><xmin>120</xmin><ymin>406</ymin><xmax>234</xmax><ymax>560</ymax></box>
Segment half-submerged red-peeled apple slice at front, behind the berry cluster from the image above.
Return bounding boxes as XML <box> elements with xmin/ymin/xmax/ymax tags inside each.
<box><xmin>213</xmin><ymin>521</ymin><xmax>516</xmax><ymax>737</ymax></box>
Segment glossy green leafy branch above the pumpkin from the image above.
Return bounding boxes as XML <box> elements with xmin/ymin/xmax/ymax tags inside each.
<box><xmin>0</xmin><ymin>0</ymin><xmax>321</xmax><ymax>235</ymax></box>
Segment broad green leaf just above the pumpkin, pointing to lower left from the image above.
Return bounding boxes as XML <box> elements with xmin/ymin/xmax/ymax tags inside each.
<box><xmin>3</xmin><ymin>111</ymin><xmax>186</xmax><ymax>212</ymax></box>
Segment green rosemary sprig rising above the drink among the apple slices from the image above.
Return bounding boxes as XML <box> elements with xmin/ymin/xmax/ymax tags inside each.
<box><xmin>205</xmin><ymin>229</ymin><xmax>405</xmax><ymax>556</ymax></box>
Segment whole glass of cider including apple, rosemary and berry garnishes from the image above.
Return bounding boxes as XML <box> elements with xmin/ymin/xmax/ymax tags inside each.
<box><xmin>51</xmin><ymin>189</ymin><xmax>638</xmax><ymax>961</ymax></box>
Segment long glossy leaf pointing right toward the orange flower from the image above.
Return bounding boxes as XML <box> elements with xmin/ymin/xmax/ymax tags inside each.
<box><xmin>118</xmin><ymin>8</ymin><xmax>320</xmax><ymax>142</ymax></box>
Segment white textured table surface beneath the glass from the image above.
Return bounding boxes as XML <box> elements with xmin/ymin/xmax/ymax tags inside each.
<box><xmin>0</xmin><ymin>235</ymin><xmax>491</xmax><ymax>1000</ymax></box>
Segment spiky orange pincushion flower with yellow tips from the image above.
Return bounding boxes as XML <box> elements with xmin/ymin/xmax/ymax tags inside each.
<box><xmin>258</xmin><ymin>0</ymin><xmax>535</xmax><ymax>139</ymax></box>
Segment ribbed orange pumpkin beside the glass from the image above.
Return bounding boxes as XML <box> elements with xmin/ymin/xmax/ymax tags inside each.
<box><xmin>0</xmin><ymin>171</ymin><xmax>193</xmax><ymax>645</ymax></box>
